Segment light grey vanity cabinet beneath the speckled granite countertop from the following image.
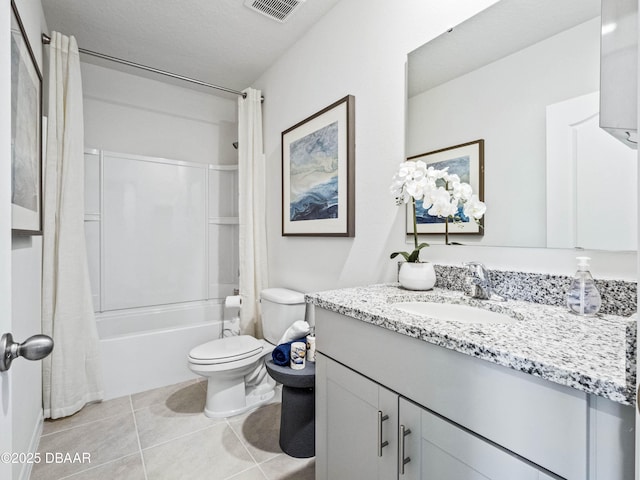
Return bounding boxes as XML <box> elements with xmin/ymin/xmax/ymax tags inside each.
<box><xmin>315</xmin><ymin>307</ymin><xmax>634</xmax><ymax>480</ymax></box>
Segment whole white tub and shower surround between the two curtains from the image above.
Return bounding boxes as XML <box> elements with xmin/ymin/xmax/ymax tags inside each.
<box><xmin>85</xmin><ymin>150</ymin><xmax>238</xmax><ymax>398</ymax></box>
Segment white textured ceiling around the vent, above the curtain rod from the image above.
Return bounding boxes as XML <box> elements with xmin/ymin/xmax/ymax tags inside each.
<box><xmin>42</xmin><ymin>0</ymin><xmax>338</xmax><ymax>97</ymax></box>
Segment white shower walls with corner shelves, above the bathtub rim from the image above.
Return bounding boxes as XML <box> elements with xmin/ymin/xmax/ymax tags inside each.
<box><xmin>85</xmin><ymin>150</ymin><xmax>238</xmax><ymax>312</ymax></box>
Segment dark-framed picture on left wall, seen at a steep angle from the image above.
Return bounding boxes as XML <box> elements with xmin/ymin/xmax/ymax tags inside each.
<box><xmin>10</xmin><ymin>0</ymin><xmax>42</xmax><ymax>235</ymax></box>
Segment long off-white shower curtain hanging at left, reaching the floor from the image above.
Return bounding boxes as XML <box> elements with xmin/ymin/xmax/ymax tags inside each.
<box><xmin>42</xmin><ymin>32</ymin><xmax>102</xmax><ymax>418</ymax></box>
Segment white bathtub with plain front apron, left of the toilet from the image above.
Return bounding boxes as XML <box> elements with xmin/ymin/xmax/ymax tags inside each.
<box><xmin>96</xmin><ymin>301</ymin><xmax>223</xmax><ymax>400</ymax></box>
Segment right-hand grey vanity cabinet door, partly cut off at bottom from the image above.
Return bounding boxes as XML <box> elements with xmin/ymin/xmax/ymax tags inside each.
<box><xmin>398</xmin><ymin>398</ymin><xmax>553</xmax><ymax>480</ymax></box>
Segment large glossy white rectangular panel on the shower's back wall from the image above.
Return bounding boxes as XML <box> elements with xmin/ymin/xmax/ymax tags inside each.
<box><xmin>102</xmin><ymin>153</ymin><xmax>207</xmax><ymax>310</ymax></box>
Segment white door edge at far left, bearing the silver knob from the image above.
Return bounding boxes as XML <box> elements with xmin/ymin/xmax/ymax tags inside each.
<box><xmin>0</xmin><ymin>2</ymin><xmax>13</xmax><ymax>478</ymax></box>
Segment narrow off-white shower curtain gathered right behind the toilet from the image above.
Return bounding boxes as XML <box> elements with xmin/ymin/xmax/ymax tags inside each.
<box><xmin>238</xmin><ymin>88</ymin><xmax>268</xmax><ymax>337</ymax></box>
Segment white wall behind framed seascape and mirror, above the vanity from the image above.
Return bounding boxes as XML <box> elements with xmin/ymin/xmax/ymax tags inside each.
<box><xmin>255</xmin><ymin>0</ymin><xmax>636</xmax><ymax>291</ymax></box>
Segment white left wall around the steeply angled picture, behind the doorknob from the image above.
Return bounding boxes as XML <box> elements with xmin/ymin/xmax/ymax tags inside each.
<box><xmin>8</xmin><ymin>0</ymin><xmax>47</xmax><ymax>478</ymax></box>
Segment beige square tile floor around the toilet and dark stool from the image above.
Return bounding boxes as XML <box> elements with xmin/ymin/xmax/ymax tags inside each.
<box><xmin>30</xmin><ymin>380</ymin><xmax>315</xmax><ymax>480</ymax></box>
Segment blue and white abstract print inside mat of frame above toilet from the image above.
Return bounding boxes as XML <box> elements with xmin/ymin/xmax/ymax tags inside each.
<box><xmin>289</xmin><ymin>122</ymin><xmax>338</xmax><ymax>222</ymax></box>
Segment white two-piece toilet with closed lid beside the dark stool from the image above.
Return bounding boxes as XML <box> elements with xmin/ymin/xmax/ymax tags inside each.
<box><xmin>188</xmin><ymin>288</ymin><xmax>305</xmax><ymax>418</ymax></box>
